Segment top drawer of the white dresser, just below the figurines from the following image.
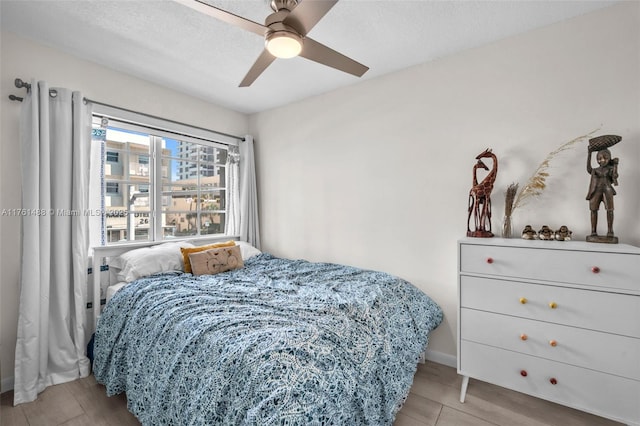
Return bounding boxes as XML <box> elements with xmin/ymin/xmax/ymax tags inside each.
<box><xmin>460</xmin><ymin>241</ymin><xmax>640</xmax><ymax>292</ymax></box>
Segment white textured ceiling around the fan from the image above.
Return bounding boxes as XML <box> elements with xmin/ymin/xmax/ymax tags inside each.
<box><xmin>0</xmin><ymin>0</ymin><xmax>616</xmax><ymax>113</ymax></box>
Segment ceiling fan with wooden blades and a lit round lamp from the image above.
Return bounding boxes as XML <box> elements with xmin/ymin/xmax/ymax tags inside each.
<box><xmin>175</xmin><ymin>0</ymin><xmax>369</xmax><ymax>87</ymax></box>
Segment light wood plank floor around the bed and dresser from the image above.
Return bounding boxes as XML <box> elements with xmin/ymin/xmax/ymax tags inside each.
<box><xmin>0</xmin><ymin>362</ymin><xmax>619</xmax><ymax>426</ymax></box>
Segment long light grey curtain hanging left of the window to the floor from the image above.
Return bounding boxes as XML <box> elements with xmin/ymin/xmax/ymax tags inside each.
<box><xmin>14</xmin><ymin>81</ymin><xmax>91</xmax><ymax>404</ymax></box>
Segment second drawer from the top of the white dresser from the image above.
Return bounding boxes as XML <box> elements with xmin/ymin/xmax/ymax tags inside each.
<box><xmin>460</xmin><ymin>276</ymin><xmax>640</xmax><ymax>338</ymax></box>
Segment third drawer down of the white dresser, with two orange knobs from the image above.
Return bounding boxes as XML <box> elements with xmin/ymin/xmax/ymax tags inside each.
<box><xmin>460</xmin><ymin>308</ymin><xmax>640</xmax><ymax>381</ymax></box>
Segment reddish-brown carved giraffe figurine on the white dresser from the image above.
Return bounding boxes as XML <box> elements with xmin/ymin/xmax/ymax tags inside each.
<box><xmin>467</xmin><ymin>148</ymin><xmax>498</xmax><ymax>238</ymax></box>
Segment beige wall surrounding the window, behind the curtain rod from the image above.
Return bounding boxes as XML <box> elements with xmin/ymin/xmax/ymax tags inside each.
<box><xmin>0</xmin><ymin>32</ymin><xmax>248</xmax><ymax>389</ymax></box>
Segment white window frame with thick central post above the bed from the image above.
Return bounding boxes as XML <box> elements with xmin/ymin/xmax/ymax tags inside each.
<box><xmin>92</xmin><ymin>104</ymin><xmax>241</xmax><ymax>246</ymax></box>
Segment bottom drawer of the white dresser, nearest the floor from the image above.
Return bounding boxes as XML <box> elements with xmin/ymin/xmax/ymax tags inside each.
<box><xmin>459</xmin><ymin>341</ymin><xmax>640</xmax><ymax>424</ymax></box>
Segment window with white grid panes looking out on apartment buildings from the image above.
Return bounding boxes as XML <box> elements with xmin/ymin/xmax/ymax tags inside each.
<box><xmin>93</xmin><ymin>115</ymin><xmax>235</xmax><ymax>244</ymax></box>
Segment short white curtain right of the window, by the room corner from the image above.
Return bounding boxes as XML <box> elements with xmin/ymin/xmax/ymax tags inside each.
<box><xmin>240</xmin><ymin>136</ymin><xmax>260</xmax><ymax>249</ymax></box>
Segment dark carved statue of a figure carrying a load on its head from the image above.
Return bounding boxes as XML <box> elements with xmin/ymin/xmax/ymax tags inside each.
<box><xmin>587</xmin><ymin>135</ymin><xmax>622</xmax><ymax>244</ymax></box>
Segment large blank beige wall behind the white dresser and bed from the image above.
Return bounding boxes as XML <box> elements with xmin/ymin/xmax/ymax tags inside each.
<box><xmin>250</xmin><ymin>2</ymin><xmax>640</xmax><ymax>359</ymax></box>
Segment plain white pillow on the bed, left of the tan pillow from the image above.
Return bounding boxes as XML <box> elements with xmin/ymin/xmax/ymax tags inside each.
<box><xmin>109</xmin><ymin>241</ymin><xmax>195</xmax><ymax>283</ymax></box>
